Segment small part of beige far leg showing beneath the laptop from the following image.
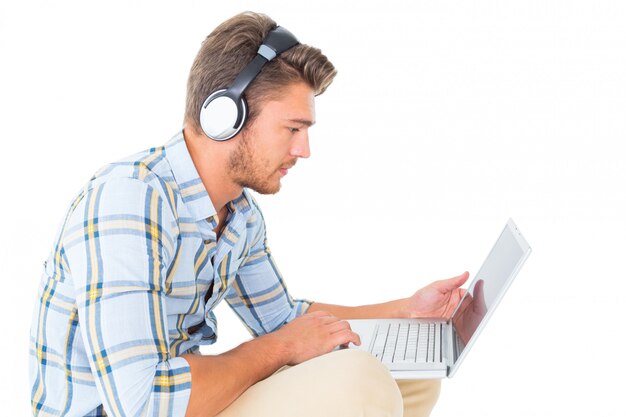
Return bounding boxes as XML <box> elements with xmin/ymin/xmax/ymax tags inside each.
<box><xmin>396</xmin><ymin>379</ymin><xmax>441</xmax><ymax>417</ymax></box>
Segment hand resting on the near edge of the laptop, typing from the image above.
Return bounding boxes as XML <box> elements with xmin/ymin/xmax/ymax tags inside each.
<box><xmin>272</xmin><ymin>311</ymin><xmax>361</xmax><ymax>365</ymax></box>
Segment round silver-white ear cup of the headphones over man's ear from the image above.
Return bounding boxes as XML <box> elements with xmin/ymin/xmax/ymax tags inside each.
<box><xmin>200</xmin><ymin>89</ymin><xmax>248</xmax><ymax>141</ymax></box>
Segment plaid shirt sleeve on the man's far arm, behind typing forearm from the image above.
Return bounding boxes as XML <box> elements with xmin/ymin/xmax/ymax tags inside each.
<box><xmin>226</xmin><ymin>203</ymin><xmax>312</xmax><ymax>337</ymax></box>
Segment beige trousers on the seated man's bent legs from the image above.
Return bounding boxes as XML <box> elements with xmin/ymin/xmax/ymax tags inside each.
<box><xmin>218</xmin><ymin>349</ymin><xmax>440</xmax><ymax>417</ymax></box>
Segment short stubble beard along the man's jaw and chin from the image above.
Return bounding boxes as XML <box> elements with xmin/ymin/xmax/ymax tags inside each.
<box><xmin>228</xmin><ymin>132</ymin><xmax>281</xmax><ymax>194</ymax></box>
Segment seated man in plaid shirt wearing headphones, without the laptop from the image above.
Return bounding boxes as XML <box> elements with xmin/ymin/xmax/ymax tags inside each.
<box><xmin>30</xmin><ymin>13</ymin><xmax>467</xmax><ymax>417</ymax></box>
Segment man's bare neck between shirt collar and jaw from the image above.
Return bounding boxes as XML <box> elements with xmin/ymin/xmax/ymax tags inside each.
<box><xmin>183</xmin><ymin>128</ymin><xmax>243</xmax><ymax>213</ymax></box>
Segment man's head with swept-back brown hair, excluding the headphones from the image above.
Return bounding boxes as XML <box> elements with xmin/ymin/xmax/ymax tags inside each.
<box><xmin>185</xmin><ymin>12</ymin><xmax>336</xmax><ymax>194</ymax></box>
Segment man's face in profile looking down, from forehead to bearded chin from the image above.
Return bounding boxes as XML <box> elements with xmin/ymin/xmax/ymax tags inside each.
<box><xmin>228</xmin><ymin>83</ymin><xmax>315</xmax><ymax>194</ymax></box>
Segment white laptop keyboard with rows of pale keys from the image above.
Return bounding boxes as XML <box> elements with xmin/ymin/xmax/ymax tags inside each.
<box><xmin>370</xmin><ymin>323</ymin><xmax>443</xmax><ymax>363</ymax></box>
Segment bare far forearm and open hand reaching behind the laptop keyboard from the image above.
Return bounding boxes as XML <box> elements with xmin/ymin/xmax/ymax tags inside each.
<box><xmin>308</xmin><ymin>272</ymin><xmax>469</xmax><ymax>320</ymax></box>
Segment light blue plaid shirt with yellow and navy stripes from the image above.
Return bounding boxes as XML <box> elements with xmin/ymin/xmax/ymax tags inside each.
<box><xmin>30</xmin><ymin>132</ymin><xmax>310</xmax><ymax>416</ymax></box>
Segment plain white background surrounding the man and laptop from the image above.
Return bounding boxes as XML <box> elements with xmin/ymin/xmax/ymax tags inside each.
<box><xmin>0</xmin><ymin>0</ymin><xmax>626</xmax><ymax>417</ymax></box>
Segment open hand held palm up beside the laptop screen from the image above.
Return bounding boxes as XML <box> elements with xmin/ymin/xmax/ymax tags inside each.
<box><xmin>407</xmin><ymin>272</ymin><xmax>469</xmax><ymax>320</ymax></box>
